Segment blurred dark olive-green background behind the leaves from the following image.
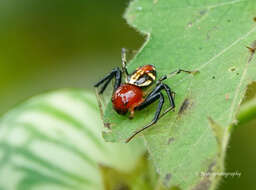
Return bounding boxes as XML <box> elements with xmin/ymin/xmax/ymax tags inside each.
<box><xmin>0</xmin><ymin>0</ymin><xmax>256</xmax><ymax>190</ymax></box>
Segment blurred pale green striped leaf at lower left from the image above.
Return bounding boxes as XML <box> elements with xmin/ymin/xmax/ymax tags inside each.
<box><xmin>0</xmin><ymin>90</ymin><xmax>145</xmax><ymax>190</ymax></box>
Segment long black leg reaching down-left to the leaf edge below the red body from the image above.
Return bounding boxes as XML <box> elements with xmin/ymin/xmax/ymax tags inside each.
<box><xmin>125</xmin><ymin>92</ymin><xmax>164</xmax><ymax>143</ymax></box>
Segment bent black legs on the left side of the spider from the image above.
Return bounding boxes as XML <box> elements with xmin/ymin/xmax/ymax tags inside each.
<box><xmin>94</xmin><ymin>67</ymin><xmax>122</xmax><ymax>94</ymax></box>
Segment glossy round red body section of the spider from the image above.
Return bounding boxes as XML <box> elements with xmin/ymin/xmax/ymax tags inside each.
<box><xmin>112</xmin><ymin>84</ymin><xmax>143</xmax><ymax>114</ymax></box>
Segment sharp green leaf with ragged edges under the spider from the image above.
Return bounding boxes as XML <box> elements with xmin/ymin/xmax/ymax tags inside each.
<box><xmin>104</xmin><ymin>0</ymin><xmax>256</xmax><ymax>190</ymax></box>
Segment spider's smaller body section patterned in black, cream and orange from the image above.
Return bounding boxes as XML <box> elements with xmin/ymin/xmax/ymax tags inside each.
<box><xmin>126</xmin><ymin>65</ymin><xmax>156</xmax><ymax>87</ymax></box>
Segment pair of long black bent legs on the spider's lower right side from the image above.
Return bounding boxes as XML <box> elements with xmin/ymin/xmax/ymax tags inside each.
<box><xmin>126</xmin><ymin>83</ymin><xmax>175</xmax><ymax>143</ymax></box>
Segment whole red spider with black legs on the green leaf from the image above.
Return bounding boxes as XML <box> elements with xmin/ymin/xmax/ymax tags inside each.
<box><xmin>94</xmin><ymin>48</ymin><xmax>195</xmax><ymax>143</ymax></box>
